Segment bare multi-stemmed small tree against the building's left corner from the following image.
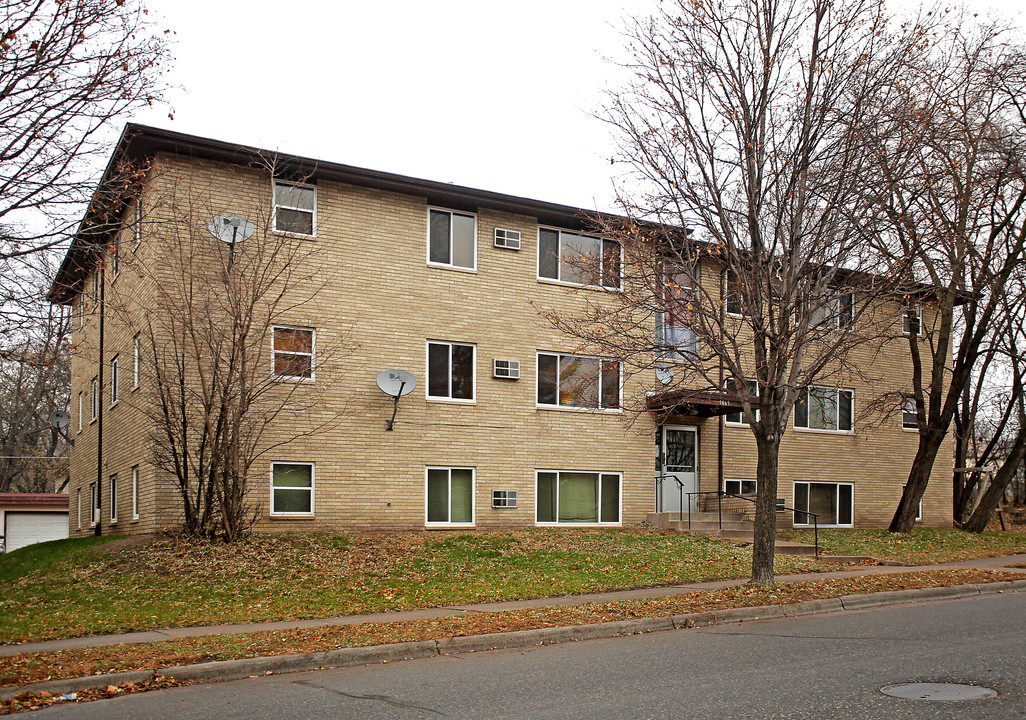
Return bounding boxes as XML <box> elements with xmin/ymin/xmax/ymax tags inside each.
<box><xmin>108</xmin><ymin>162</ymin><xmax>351</xmax><ymax>542</ymax></box>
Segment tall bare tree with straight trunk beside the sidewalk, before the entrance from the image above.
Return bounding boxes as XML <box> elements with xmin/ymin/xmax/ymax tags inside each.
<box><xmin>547</xmin><ymin>0</ymin><xmax>900</xmax><ymax>583</ymax></box>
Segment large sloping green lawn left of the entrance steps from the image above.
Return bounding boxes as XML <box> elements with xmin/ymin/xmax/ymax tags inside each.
<box><xmin>0</xmin><ymin>528</ymin><xmax>815</xmax><ymax>643</ymax></box>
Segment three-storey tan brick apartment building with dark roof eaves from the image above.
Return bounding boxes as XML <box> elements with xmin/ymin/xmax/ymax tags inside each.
<box><xmin>50</xmin><ymin>125</ymin><xmax>950</xmax><ymax>535</ymax></box>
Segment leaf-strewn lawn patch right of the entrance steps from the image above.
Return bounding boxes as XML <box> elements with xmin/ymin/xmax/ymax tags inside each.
<box><xmin>778</xmin><ymin>528</ymin><xmax>1026</xmax><ymax>565</ymax></box>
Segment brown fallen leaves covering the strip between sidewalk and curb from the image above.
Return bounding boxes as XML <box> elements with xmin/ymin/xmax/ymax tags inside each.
<box><xmin>0</xmin><ymin>570</ymin><xmax>1022</xmax><ymax>714</ymax></box>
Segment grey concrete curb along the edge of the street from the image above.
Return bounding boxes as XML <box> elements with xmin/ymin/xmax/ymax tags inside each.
<box><xmin>0</xmin><ymin>579</ymin><xmax>1026</xmax><ymax>701</ymax></box>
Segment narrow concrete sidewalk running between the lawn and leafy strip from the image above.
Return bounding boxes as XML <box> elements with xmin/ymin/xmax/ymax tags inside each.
<box><xmin>0</xmin><ymin>554</ymin><xmax>1026</xmax><ymax>656</ymax></box>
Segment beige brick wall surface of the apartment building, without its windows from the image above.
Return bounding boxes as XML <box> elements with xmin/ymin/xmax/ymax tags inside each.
<box><xmin>71</xmin><ymin>156</ymin><xmax>950</xmax><ymax>534</ymax></box>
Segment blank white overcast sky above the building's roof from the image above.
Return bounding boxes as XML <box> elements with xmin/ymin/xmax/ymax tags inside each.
<box><xmin>133</xmin><ymin>0</ymin><xmax>1018</xmax><ymax>209</ymax></box>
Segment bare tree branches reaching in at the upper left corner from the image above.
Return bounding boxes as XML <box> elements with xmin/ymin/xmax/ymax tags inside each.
<box><xmin>0</xmin><ymin>0</ymin><xmax>168</xmax><ymax>338</ymax></box>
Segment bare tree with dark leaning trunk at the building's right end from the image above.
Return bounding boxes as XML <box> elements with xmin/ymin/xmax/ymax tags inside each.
<box><xmin>867</xmin><ymin>22</ymin><xmax>1026</xmax><ymax>532</ymax></box>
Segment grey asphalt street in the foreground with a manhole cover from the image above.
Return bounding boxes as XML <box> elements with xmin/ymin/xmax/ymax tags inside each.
<box><xmin>31</xmin><ymin>593</ymin><xmax>1026</xmax><ymax>720</ymax></box>
